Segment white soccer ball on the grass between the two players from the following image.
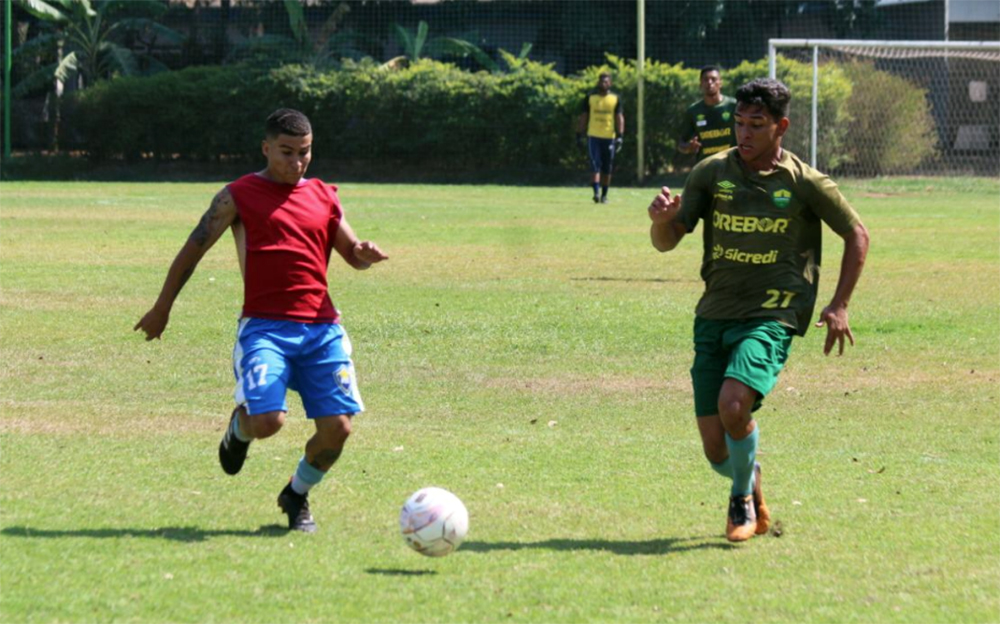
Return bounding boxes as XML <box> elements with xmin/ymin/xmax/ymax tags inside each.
<box><xmin>399</xmin><ymin>487</ymin><xmax>469</xmax><ymax>557</ymax></box>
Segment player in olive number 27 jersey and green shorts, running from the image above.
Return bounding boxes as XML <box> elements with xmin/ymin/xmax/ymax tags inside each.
<box><xmin>649</xmin><ymin>79</ymin><xmax>868</xmax><ymax>542</ymax></box>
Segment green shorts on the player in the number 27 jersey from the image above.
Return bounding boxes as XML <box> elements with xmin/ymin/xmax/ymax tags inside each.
<box><xmin>691</xmin><ymin>317</ymin><xmax>795</xmax><ymax>416</ymax></box>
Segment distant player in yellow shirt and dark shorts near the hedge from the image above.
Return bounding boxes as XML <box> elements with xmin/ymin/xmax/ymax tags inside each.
<box><xmin>576</xmin><ymin>73</ymin><xmax>625</xmax><ymax>204</ymax></box>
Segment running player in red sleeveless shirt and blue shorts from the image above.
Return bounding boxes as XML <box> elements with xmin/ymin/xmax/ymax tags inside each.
<box><xmin>135</xmin><ymin>109</ymin><xmax>388</xmax><ymax>533</ymax></box>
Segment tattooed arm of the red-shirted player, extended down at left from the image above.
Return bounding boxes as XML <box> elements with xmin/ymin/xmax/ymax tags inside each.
<box><xmin>133</xmin><ymin>189</ymin><xmax>237</xmax><ymax>340</ymax></box>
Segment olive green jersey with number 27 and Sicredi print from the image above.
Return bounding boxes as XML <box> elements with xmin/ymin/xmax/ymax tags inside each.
<box><xmin>677</xmin><ymin>149</ymin><xmax>860</xmax><ymax>336</ymax></box>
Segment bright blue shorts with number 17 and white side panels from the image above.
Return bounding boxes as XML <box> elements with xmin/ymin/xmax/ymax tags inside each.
<box><xmin>233</xmin><ymin>318</ymin><xmax>365</xmax><ymax>418</ymax></box>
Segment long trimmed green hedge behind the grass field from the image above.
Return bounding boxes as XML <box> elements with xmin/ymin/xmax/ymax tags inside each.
<box><xmin>67</xmin><ymin>55</ymin><xmax>927</xmax><ymax>182</ymax></box>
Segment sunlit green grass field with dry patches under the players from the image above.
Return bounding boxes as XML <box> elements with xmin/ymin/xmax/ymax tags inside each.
<box><xmin>0</xmin><ymin>179</ymin><xmax>1000</xmax><ymax>622</ymax></box>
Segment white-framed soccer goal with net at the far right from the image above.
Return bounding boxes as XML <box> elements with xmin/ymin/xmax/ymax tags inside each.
<box><xmin>768</xmin><ymin>39</ymin><xmax>1000</xmax><ymax>177</ymax></box>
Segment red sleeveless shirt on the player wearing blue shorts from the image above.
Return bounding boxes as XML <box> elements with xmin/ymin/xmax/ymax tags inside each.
<box><xmin>227</xmin><ymin>173</ymin><xmax>343</xmax><ymax>323</ymax></box>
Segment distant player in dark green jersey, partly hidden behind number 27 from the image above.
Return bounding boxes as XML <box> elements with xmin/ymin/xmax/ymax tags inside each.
<box><xmin>677</xmin><ymin>65</ymin><xmax>736</xmax><ymax>160</ymax></box>
